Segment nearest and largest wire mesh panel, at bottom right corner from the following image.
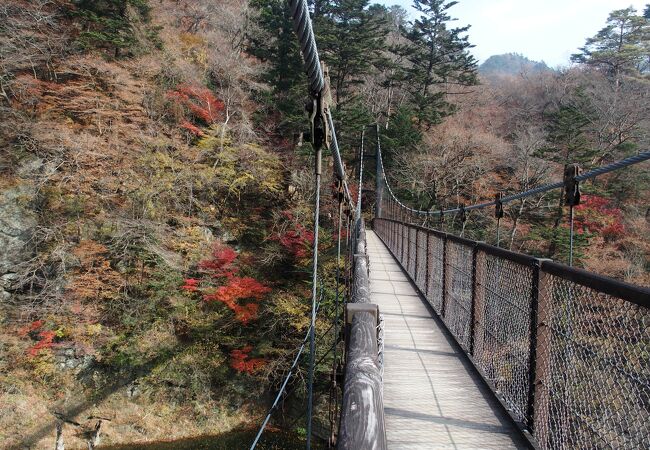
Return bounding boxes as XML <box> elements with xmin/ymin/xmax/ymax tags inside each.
<box><xmin>533</xmin><ymin>273</ymin><xmax>650</xmax><ymax>449</ymax></box>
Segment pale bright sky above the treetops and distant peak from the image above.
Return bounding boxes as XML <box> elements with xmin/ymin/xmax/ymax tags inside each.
<box><xmin>377</xmin><ymin>0</ymin><xmax>650</xmax><ymax>67</ymax></box>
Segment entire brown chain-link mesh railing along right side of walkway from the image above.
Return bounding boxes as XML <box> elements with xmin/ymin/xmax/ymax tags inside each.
<box><xmin>374</xmin><ymin>216</ymin><xmax>650</xmax><ymax>449</ymax></box>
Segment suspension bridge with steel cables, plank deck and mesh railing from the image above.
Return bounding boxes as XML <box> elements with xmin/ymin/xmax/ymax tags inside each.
<box><xmin>251</xmin><ymin>0</ymin><xmax>650</xmax><ymax>450</ymax></box>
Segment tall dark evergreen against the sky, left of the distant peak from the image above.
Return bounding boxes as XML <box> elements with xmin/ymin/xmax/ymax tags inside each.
<box><xmin>399</xmin><ymin>0</ymin><xmax>478</xmax><ymax>125</ymax></box>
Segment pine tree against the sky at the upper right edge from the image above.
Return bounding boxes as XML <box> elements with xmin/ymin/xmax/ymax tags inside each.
<box><xmin>571</xmin><ymin>7</ymin><xmax>650</xmax><ymax>86</ymax></box>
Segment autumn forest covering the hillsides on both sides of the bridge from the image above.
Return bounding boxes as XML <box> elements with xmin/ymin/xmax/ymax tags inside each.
<box><xmin>0</xmin><ymin>0</ymin><xmax>650</xmax><ymax>448</ymax></box>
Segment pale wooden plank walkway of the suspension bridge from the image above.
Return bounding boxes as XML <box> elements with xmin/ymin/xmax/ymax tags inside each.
<box><xmin>367</xmin><ymin>230</ymin><xmax>527</xmax><ymax>449</ymax></box>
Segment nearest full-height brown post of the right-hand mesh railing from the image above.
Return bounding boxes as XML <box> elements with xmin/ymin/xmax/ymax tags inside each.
<box><xmin>526</xmin><ymin>259</ymin><xmax>552</xmax><ymax>448</ymax></box>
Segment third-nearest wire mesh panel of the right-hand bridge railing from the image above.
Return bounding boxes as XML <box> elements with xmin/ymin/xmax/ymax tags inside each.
<box><xmin>444</xmin><ymin>240</ymin><xmax>473</xmax><ymax>350</ymax></box>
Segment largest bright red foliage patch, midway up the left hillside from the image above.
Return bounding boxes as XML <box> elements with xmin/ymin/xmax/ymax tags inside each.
<box><xmin>181</xmin><ymin>243</ymin><xmax>271</xmax><ymax>325</ymax></box>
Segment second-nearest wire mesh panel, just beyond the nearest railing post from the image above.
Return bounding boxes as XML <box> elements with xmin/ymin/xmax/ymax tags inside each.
<box><xmin>472</xmin><ymin>250</ymin><xmax>534</xmax><ymax>422</ymax></box>
